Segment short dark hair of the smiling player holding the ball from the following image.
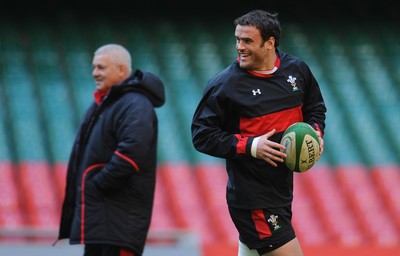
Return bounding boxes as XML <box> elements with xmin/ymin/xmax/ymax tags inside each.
<box><xmin>233</xmin><ymin>10</ymin><xmax>281</xmax><ymax>47</ymax></box>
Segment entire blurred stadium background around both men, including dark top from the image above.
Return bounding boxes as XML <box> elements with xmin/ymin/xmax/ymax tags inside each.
<box><xmin>0</xmin><ymin>0</ymin><xmax>400</xmax><ymax>256</ymax></box>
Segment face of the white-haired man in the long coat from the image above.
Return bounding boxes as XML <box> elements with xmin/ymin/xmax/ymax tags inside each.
<box><xmin>92</xmin><ymin>53</ymin><xmax>125</xmax><ymax>92</ymax></box>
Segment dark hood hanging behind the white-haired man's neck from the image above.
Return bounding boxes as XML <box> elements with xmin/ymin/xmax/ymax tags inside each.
<box><xmin>109</xmin><ymin>69</ymin><xmax>165</xmax><ymax>107</ymax></box>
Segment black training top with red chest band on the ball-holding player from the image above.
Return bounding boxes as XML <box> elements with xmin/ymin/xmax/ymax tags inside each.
<box><xmin>192</xmin><ymin>51</ymin><xmax>326</xmax><ymax>209</ymax></box>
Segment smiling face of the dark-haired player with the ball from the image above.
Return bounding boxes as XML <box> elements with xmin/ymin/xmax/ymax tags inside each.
<box><xmin>235</xmin><ymin>25</ymin><xmax>275</xmax><ymax>70</ymax></box>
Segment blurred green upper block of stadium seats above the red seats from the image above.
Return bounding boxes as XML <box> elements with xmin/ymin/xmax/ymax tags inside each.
<box><xmin>0</xmin><ymin>17</ymin><xmax>400</xmax><ymax>166</ymax></box>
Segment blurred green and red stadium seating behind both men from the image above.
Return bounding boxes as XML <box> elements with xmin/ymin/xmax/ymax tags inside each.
<box><xmin>0</xmin><ymin>17</ymin><xmax>400</xmax><ymax>248</ymax></box>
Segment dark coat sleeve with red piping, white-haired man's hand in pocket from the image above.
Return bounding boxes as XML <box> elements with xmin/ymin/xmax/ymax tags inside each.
<box><xmin>93</xmin><ymin>93</ymin><xmax>157</xmax><ymax>192</ymax></box>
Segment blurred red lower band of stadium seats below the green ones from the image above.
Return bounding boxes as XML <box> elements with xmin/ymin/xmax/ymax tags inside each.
<box><xmin>0</xmin><ymin>162</ymin><xmax>400</xmax><ymax>246</ymax></box>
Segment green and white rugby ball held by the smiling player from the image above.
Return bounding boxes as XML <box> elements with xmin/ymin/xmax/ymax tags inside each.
<box><xmin>281</xmin><ymin>122</ymin><xmax>319</xmax><ymax>172</ymax></box>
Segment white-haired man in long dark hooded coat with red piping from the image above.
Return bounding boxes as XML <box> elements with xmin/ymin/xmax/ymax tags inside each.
<box><xmin>58</xmin><ymin>44</ymin><xmax>165</xmax><ymax>256</ymax></box>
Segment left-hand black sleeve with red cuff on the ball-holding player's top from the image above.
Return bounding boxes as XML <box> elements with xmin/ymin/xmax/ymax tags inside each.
<box><xmin>191</xmin><ymin>82</ymin><xmax>253</xmax><ymax>158</ymax></box>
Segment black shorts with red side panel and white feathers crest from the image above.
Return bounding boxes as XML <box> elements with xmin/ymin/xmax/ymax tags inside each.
<box><xmin>229</xmin><ymin>206</ymin><xmax>296</xmax><ymax>255</ymax></box>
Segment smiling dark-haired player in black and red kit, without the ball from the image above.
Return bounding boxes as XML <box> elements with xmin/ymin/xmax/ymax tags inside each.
<box><xmin>192</xmin><ymin>10</ymin><xmax>326</xmax><ymax>256</ymax></box>
